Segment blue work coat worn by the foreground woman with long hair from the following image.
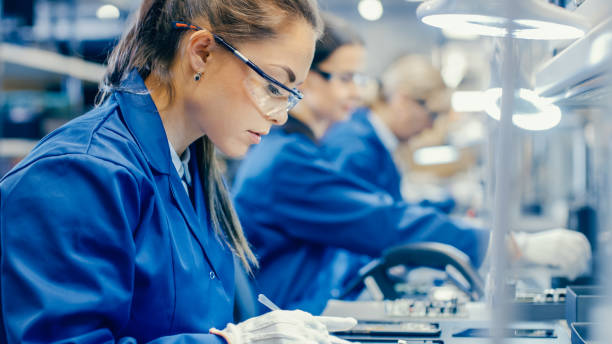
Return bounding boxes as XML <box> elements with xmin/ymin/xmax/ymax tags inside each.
<box><xmin>0</xmin><ymin>72</ymin><xmax>234</xmax><ymax>343</ymax></box>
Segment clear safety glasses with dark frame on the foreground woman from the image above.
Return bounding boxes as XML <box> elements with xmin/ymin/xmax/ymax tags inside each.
<box><xmin>173</xmin><ymin>21</ymin><xmax>304</xmax><ymax>119</ymax></box>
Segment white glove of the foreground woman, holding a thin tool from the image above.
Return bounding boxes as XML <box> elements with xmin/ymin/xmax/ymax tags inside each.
<box><xmin>210</xmin><ymin>310</ymin><xmax>357</xmax><ymax>344</ymax></box>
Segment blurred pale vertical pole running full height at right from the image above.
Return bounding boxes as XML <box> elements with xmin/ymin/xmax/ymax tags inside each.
<box><xmin>491</xmin><ymin>5</ymin><xmax>517</xmax><ymax>344</ymax></box>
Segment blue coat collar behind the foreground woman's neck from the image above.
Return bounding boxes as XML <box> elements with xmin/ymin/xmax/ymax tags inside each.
<box><xmin>114</xmin><ymin>69</ymin><xmax>174</xmax><ymax>174</ymax></box>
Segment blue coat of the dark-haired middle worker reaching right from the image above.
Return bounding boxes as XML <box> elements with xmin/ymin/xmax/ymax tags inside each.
<box><xmin>232</xmin><ymin>117</ymin><xmax>489</xmax><ymax>313</ymax></box>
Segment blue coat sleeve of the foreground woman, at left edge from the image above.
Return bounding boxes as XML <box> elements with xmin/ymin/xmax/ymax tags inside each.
<box><xmin>0</xmin><ymin>154</ymin><xmax>222</xmax><ymax>343</ymax></box>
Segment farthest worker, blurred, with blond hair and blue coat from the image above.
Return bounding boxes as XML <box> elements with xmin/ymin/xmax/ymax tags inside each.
<box><xmin>321</xmin><ymin>55</ymin><xmax>454</xmax><ymax>208</ymax></box>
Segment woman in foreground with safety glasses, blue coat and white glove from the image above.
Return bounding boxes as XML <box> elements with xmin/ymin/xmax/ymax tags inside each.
<box><xmin>0</xmin><ymin>0</ymin><xmax>356</xmax><ymax>344</ymax></box>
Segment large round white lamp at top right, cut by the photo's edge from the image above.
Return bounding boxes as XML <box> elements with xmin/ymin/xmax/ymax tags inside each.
<box><xmin>417</xmin><ymin>0</ymin><xmax>589</xmax><ymax>39</ymax></box>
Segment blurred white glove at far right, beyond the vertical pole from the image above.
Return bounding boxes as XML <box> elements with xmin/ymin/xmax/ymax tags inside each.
<box><xmin>514</xmin><ymin>228</ymin><xmax>591</xmax><ymax>280</ymax></box>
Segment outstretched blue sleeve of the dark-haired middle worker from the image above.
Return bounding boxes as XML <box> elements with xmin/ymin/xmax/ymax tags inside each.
<box><xmin>237</xmin><ymin>148</ymin><xmax>489</xmax><ymax>265</ymax></box>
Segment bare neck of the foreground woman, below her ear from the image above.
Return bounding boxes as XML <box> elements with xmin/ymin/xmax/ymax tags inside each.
<box><xmin>145</xmin><ymin>74</ymin><xmax>202</xmax><ymax>156</ymax></box>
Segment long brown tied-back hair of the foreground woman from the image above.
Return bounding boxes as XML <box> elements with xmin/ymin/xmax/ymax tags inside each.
<box><xmin>98</xmin><ymin>0</ymin><xmax>322</xmax><ymax>272</ymax></box>
